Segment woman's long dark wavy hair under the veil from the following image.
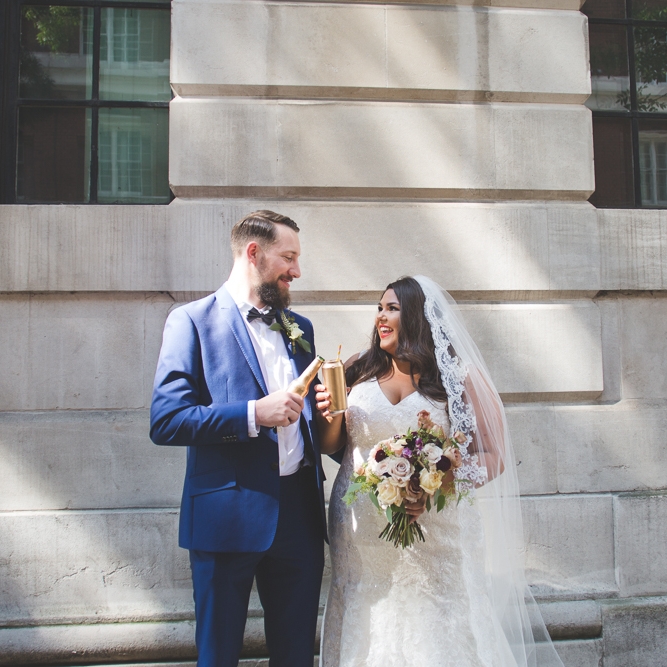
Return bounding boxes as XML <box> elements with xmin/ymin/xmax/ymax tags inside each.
<box><xmin>345</xmin><ymin>277</ymin><xmax>447</xmax><ymax>403</ymax></box>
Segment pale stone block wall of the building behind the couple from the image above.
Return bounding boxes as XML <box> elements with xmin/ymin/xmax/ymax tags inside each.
<box><xmin>0</xmin><ymin>0</ymin><xmax>667</xmax><ymax>667</ymax></box>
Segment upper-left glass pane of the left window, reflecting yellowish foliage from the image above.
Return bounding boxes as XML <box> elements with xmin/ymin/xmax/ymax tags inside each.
<box><xmin>19</xmin><ymin>6</ymin><xmax>93</xmax><ymax>100</ymax></box>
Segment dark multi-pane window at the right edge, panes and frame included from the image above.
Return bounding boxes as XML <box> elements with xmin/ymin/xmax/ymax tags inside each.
<box><xmin>582</xmin><ymin>0</ymin><xmax>667</xmax><ymax>208</ymax></box>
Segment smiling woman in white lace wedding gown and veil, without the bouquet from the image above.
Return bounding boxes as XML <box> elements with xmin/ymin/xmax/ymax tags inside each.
<box><xmin>315</xmin><ymin>276</ymin><xmax>562</xmax><ymax>667</ymax></box>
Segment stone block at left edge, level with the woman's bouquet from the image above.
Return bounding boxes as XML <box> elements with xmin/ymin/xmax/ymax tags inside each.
<box><xmin>0</xmin><ymin>410</ymin><xmax>185</xmax><ymax>511</ymax></box>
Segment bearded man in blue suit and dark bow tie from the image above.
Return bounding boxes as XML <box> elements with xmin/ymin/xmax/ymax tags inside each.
<box><xmin>151</xmin><ymin>211</ymin><xmax>326</xmax><ymax>667</ymax></box>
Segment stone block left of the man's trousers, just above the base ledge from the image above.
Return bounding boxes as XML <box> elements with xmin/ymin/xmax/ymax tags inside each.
<box><xmin>0</xmin><ymin>508</ymin><xmax>193</xmax><ymax>628</ymax></box>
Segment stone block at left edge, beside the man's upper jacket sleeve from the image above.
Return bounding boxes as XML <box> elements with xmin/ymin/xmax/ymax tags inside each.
<box><xmin>0</xmin><ymin>293</ymin><xmax>173</xmax><ymax>411</ymax></box>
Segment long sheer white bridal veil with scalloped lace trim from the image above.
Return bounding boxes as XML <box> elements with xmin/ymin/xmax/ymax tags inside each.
<box><xmin>414</xmin><ymin>276</ymin><xmax>563</xmax><ymax>667</ymax></box>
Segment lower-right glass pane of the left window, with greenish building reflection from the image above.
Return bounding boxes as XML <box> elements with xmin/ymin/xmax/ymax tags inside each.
<box><xmin>97</xmin><ymin>109</ymin><xmax>169</xmax><ymax>204</ymax></box>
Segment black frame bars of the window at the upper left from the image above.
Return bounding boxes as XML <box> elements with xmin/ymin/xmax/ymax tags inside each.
<box><xmin>0</xmin><ymin>0</ymin><xmax>174</xmax><ymax>206</ymax></box>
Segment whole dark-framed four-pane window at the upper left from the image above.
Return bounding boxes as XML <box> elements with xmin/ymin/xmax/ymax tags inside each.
<box><xmin>0</xmin><ymin>0</ymin><xmax>171</xmax><ymax>204</ymax></box>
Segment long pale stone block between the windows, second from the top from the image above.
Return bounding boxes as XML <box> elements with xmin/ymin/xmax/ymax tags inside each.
<box><xmin>169</xmin><ymin>98</ymin><xmax>594</xmax><ymax>200</ymax></box>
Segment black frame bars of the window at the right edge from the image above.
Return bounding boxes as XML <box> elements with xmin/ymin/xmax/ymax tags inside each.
<box><xmin>582</xmin><ymin>0</ymin><xmax>667</xmax><ymax>209</ymax></box>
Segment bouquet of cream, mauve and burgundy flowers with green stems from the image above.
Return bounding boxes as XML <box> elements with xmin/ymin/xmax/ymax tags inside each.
<box><xmin>344</xmin><ymin>410</ymin><xmax>469</xmax><ymax>549</ymax></box>
